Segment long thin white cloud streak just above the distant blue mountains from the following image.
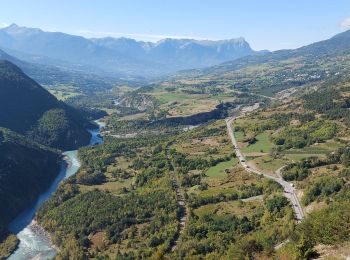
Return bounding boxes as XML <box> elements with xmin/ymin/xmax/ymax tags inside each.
<box><xmin>74</xmin><ymin>30</ymin><xmax>213</xmax><ymax>41</ymax></box>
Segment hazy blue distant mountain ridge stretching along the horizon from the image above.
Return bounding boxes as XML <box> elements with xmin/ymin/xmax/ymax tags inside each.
<box><xmin>0</xmin><ymin>24</ymin><xmax>258</xmax><ymax>76</ymax></box>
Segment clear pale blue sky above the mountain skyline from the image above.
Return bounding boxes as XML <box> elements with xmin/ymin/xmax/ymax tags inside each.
<box><xmin>0</xmin><ymin>0</ymin><xmax>350</xmax><ymax>50</ymax></box>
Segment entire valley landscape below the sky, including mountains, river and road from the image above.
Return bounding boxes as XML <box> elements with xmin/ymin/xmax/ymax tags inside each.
<box><xmin>0</xmin><ymin>9</ymin><xmax>350</xmax><ymax>260</ymax></box>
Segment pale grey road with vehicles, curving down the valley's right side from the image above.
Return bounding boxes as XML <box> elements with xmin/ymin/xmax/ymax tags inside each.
<box><xmin>225</xmin><ymin>117</ymin><xmax>304</xmax><ymax>222</ymax></box>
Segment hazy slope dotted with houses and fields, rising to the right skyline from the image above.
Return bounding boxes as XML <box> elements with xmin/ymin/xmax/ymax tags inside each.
<box><xmin>171</xmin><ymin>27</ymin><xmax>350</xmax><ymax>96</ymax></box>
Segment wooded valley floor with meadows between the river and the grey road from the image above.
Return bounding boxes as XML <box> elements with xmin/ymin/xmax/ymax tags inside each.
<box><xmin>37</xmin><ymin>106</ymin><xmax>295</xmax><ymax>259</ymax></box>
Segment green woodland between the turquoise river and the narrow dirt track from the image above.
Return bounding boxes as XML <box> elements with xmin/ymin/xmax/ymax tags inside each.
<box><xmin>37</xmin><ymin>136</ymin><xmax>179</xmax><ymax>259</ymax></box>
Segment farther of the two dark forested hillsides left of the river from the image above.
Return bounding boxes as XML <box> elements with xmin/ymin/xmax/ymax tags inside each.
<box><xmin>0</xmin><ymin>61</ymin><xmax>90</xmax><ymax>149</ymax></box>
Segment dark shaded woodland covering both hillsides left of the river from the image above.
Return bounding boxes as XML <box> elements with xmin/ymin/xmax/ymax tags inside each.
<box><xmin>0</xmin><ymin>61</ymin><xmax>93</xmax><ymax>258</ymax></box>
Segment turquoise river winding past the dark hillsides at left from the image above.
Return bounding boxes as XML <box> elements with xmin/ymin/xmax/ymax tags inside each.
<box><xmin>8</xmin><ymin>120</ymin><xmax>104</xmax><ymax>260</ymax></box>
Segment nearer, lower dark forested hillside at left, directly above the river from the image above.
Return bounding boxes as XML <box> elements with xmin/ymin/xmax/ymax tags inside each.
<box><xmin>0</xmin><ymin>128</ymin><xmax>60</xmax><ymax>246</ymax></box>
